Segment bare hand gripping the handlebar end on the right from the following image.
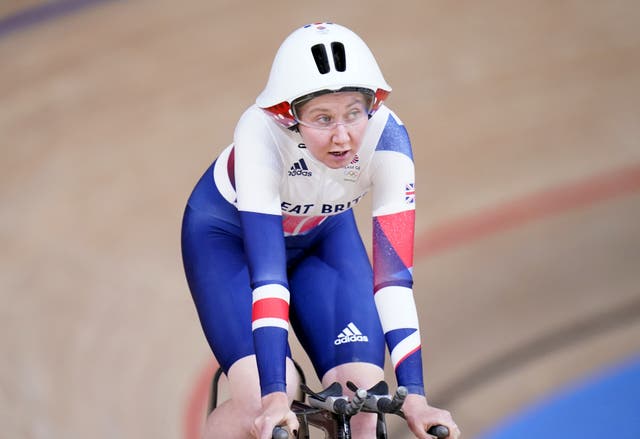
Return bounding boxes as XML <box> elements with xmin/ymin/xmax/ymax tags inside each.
<box><xmin>402</xmin><ymin>394</ymin><xmax>460</xmax><ymax>439</ymax></box>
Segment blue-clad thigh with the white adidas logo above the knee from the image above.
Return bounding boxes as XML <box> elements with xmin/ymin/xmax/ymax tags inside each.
<box><xmin>289</xmin><ymin>212</ymin><xmax>385</xmax><ymax>377</ymax></box>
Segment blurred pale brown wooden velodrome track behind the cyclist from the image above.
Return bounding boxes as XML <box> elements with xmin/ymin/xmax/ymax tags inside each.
<box><xmin>0</xmin><ymin>0</ymin><xmax>640</xmax><ymax>439</ymax></box>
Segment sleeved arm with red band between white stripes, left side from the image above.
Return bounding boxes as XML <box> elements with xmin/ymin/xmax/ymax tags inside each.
<box><xmin>234</xmin><ymin>109</ymin><xmax>289</xmax><ymax>396</ymax></box>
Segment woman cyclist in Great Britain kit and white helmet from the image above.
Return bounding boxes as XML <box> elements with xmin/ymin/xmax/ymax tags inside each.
<box><xmin>182</xmin><ymin>23</ymin><xmax>459</xmax><ymax>439</ymax></box>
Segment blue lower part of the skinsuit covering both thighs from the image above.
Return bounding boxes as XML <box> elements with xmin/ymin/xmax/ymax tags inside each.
<box><xmin>182</xmin><ymin>163</ymin><xmax>385</xmax><ymax>378</ymax></box>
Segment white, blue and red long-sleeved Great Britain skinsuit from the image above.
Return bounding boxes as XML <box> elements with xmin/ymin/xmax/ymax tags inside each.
<box><xmin>182</xmin><ymin>105</ymin><xmax>424</xmax><ymax>395</ymax></box>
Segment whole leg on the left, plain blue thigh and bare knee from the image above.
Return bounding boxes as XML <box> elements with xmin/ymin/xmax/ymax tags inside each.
<box><xmin>182</xmin><ymin>208</ymin><xmax>297</xmax><ymax>439</ymax></box>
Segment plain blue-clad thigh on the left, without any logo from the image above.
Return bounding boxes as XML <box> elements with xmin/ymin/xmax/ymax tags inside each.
<box><xmin>182</xmin><ymin>207</ymin><xmax>254</xmax><ymax>372</ymax></box>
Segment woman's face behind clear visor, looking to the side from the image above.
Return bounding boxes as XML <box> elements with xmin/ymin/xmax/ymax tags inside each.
<box><xmin>298</xmin><ymin>92</ymin><xmax>368</xmax><ymax>169</ymax></box>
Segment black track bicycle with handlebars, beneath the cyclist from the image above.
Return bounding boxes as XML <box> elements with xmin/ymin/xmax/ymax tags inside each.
<box><xmin>207</xmin><ymin>361</ymin><xmax>449</xmax><ymax>439</ymax></box>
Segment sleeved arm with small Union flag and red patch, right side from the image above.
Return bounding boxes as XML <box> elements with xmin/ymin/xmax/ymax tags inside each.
<box><xmin>373</xmin><ymin>113</ymin><xmax>424</xmax><ymax>395</ymax></box>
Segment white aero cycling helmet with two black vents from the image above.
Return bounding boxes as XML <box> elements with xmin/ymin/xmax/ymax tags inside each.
<box><xmin>256</xmin><ymin>23</ymin><xmax>391</xmax><ymax>128</ymax></box>
